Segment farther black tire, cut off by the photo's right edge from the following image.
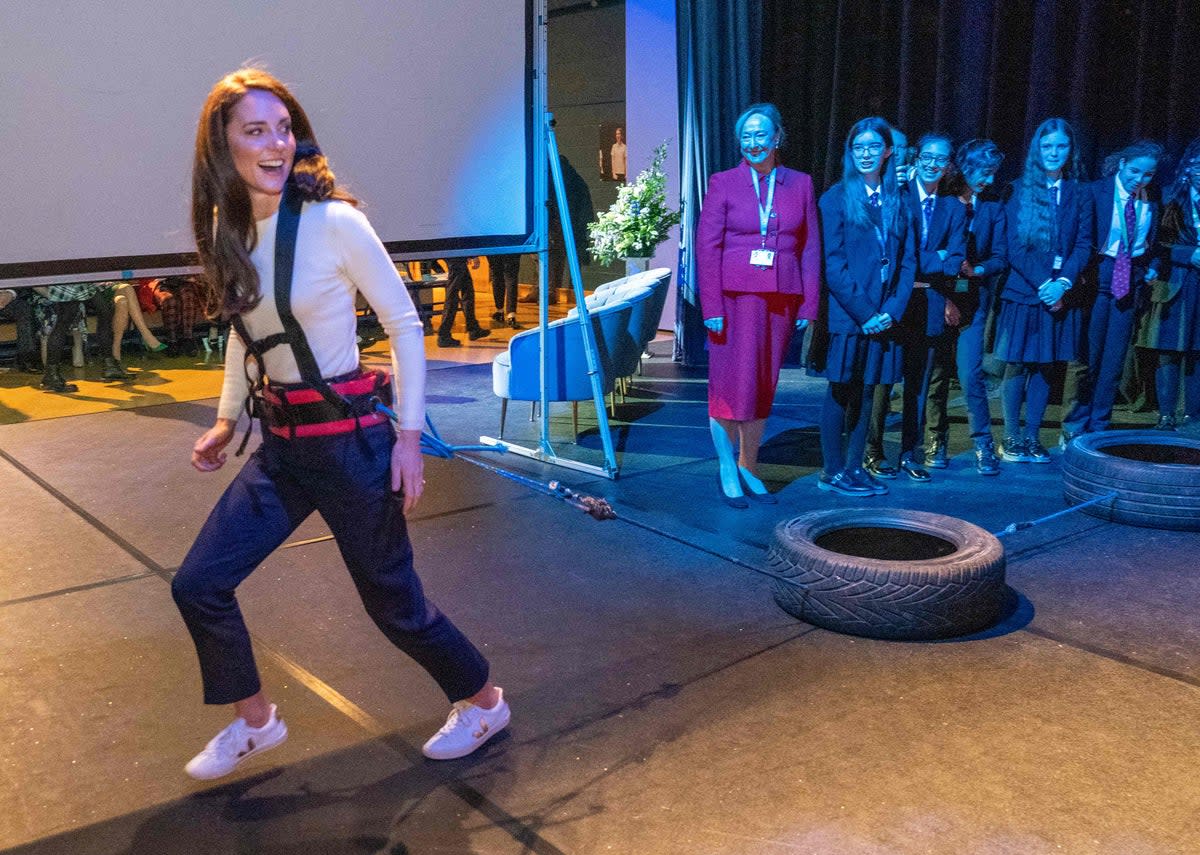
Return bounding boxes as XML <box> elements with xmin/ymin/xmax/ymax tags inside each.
<box><xmin>1062</xmin><ymin>430</ymin><xmax>1200</xmax><ymax>532</ymax></box>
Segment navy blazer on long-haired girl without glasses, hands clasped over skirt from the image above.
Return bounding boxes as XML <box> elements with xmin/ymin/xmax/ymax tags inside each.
<box><xmin>1001</xmin><ymin>179</ymin><xmax>1093</xmax><ymax>306</ymax></box>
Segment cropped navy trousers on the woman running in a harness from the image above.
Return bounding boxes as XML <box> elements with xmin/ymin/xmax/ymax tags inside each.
<box><xmin>172</xmin><ymin>424</ymin><xmax>488</xmax><ymax>704</ymax></box>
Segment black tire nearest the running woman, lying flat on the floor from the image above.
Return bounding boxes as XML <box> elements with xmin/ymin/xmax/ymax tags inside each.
<box><xmin>767</xmin><ymin>509</ymin><xmax>1008</xmax><ymax>640</ymax></box>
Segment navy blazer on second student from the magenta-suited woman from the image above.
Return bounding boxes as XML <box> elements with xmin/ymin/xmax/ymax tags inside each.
<box><xmin>902</xmin><ymin>179</ymin><xmax>967</xmax><ymax>335</ymax></box>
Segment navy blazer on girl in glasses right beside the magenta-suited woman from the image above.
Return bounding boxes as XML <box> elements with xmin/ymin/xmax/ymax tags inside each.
<box><xmin>818</xmin><ymin>181</ymin><xmax>917</xmax><ymax>335</ymax></box>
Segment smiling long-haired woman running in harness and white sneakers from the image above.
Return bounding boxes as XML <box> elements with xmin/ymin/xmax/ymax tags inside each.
<box><xmin>172</xmin><ymin>68</ymin><xmax>509</xmax><ymax>779</ymax></box>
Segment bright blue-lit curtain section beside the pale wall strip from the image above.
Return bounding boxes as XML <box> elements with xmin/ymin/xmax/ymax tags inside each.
<box><xmin>674</xmin><ymin>0</ymin><xmax>762</xmax><ymax>365</ymax></box>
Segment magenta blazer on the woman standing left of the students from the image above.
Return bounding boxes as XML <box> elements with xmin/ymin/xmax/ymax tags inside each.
<box><xmin>696</xmin><ymin>161</ymin><xmax>821</xmax><ymax>321</ymax></box>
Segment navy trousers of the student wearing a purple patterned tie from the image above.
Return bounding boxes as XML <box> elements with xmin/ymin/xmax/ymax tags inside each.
<box><xmin>1062</xmin><ymin>256</ymin><xmax>1146</xmax><ymax>436</ymax></box>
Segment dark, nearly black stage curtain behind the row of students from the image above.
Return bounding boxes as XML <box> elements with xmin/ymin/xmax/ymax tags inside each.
<box><xmin>761</xmin><ymin>0</ymin><xmax>1200</xmax><ymax>187</ymax></box>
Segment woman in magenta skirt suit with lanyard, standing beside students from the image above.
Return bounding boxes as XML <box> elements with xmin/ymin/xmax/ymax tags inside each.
<box><xmin>696</xmin><ymin>104</ymin><xmax>821</xmax><ymax>508</ymax></box>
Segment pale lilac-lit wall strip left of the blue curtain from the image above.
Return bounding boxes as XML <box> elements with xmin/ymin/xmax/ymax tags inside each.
<box><xmin>625</xmin><ymin>0</ymin><xmax>679</xmax><ymax>329</ymax></box>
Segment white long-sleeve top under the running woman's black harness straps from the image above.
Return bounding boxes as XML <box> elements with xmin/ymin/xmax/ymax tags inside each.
<box><xmin>217</xmin><ymin>201</ymin><xmax>425</xmax><ymax>430</ymax></box>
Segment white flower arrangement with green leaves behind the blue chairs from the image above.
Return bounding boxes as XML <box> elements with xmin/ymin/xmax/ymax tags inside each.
<box><xmin>588</xmin><ymin>142</ymin><xmax>679</xmax><ymax>264</ymax></box>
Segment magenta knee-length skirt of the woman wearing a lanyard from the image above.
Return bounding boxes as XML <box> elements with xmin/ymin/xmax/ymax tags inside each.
<box><xmin>708</xmin><ymin>292</ymin><xmax>800</xmax><ymax>421</ymax></box>
